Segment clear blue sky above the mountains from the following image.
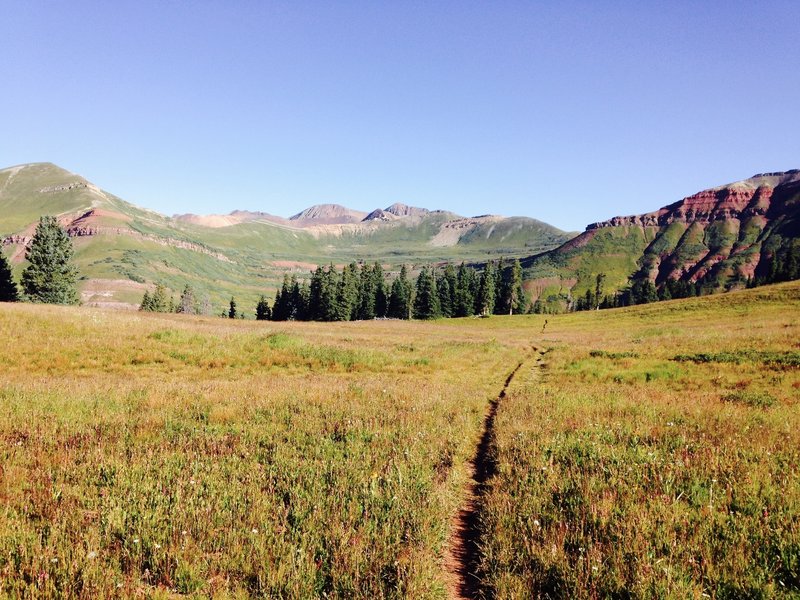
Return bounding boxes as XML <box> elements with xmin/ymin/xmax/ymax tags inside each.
<box><xmin>0</xmin><ymin>0</ymin><xmax>800</xmax><ymax>230</ymax></box>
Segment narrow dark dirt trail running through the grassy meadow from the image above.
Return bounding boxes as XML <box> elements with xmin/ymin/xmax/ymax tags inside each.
<box><xmin>444</xmin><ymin>347</ymin><xmax>544</xmax><ymax>600</ymax></box>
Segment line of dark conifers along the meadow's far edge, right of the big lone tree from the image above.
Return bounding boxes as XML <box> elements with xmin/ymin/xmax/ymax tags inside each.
<box><xmin>140</xmin><ymin>245</ymin><xmax>800</xmax><ymax>321</ymax></box>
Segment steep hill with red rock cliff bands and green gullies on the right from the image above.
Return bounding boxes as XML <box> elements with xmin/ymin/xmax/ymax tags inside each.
<box><xmin>523</xmin><ymin>170</ymin><xmax>800</xmax><ymax>312</ymax></box>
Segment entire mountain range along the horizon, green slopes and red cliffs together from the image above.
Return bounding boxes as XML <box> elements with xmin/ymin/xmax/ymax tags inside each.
<box><xmin>0</xmin><ymin>163</ymin><xmax>800</xmax><ymax>310</ymax></box>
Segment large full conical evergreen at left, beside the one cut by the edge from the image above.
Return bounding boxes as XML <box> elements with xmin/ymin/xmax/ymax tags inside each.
<box><xmin>22</xmin><ymin>216</ymin><xmax>78</xmax><ymax>304</ymax></box>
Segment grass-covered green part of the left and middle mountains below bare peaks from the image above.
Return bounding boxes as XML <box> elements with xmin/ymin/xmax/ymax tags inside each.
<box><xmin>0</xmin><ymin>163</ymin><xmax>570</xmax><ymax>313</ymax></box>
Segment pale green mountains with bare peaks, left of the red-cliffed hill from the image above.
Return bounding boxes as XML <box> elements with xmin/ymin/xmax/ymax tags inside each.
<box><xmin>0</xmin><ymin>163</ymin><xmax>573</xmax><ymax>313</ymax></box>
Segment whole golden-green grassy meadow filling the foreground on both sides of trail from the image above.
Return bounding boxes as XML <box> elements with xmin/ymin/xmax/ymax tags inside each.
<box><xmin>0</xmin><ymin>283</ymin><xmax>800</xmax><ymax>599</ymax></box>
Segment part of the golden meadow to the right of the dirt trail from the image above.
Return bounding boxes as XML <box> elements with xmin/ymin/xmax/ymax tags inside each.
<box><xmin>472</xmin><ymin>283</ymin><xmax>800</xmax><ymax>599</ymax></box>
